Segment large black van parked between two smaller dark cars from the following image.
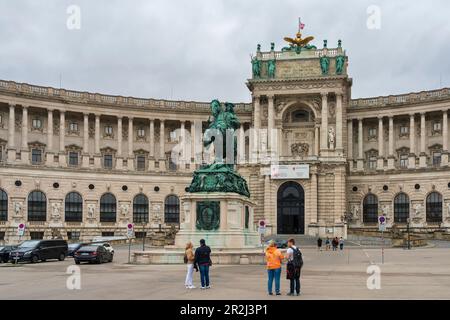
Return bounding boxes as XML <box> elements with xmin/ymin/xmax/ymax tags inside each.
<box><xmin>9</xmin><ymin>240</ymin><xmax>67</xmax><ymax>263</ymax></box>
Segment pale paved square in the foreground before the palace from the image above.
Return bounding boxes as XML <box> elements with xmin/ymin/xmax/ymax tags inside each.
<box><xmin>0</xmin><ymin>246</ymin><xmax>450</xmax><ymax>300</ymax></box>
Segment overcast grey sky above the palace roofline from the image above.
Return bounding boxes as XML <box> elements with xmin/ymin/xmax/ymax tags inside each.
<box><xmin>0</xmin><ymin>0</ymin><xmax>450</xmax><ymax>102</ymax></box>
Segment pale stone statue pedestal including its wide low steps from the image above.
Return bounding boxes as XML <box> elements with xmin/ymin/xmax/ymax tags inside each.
<box><xmin>133</xmin><ymin>192</ymin><xmax>264</xmax><ymax>264</ymax></box>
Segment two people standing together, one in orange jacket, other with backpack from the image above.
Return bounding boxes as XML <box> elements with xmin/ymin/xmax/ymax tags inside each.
<box><xmin>266</xmin><ymin>239</ymin><xmax>303</xmax><ymax>296</ymax></box>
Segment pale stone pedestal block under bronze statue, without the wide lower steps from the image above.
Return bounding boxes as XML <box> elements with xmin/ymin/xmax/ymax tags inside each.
<box><xmin>175</xmin><ymin>192</ymin><xmax>260</xmax><ymax>250</ymax></box>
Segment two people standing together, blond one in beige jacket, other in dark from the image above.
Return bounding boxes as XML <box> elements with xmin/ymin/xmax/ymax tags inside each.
<box><xmin>184</xmin><ymin>239</ymin><xmax>212</xmax><ymax>290</ymax></box>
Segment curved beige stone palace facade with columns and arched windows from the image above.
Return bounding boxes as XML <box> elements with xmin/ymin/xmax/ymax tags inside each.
<box><xmin>0</xmin><ymin>37</ymin><xmax>450</xmax><ymax>242</ymax></box>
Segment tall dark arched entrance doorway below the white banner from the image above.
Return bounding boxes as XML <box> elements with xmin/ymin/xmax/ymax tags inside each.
<box><xmin>277</xmin><ymin>182</ymin><xmax>305</xmax><ymax>234</ymax></box>
